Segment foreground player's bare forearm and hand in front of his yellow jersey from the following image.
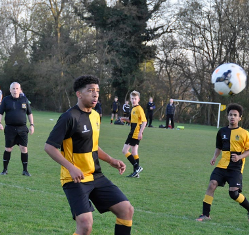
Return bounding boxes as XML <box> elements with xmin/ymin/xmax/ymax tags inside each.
<box><xmin>44</xmin><ymin>143</ymin><xmax>84</xmax><ymax>183</ymax></box>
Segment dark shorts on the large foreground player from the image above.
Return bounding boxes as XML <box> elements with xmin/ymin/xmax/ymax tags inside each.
<box><xmin>63</xmin><ymin>176</ymin><xmax>128</xmax><ymax>219</ymax></box>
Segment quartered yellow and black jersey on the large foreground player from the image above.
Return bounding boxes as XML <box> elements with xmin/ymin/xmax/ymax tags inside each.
<box><xmin>46</xmin><ymin>105</ymin><xmax>103</xmax><ymax>185</ymax></box>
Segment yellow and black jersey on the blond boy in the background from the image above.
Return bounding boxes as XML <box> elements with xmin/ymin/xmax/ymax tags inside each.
<box><xmin>128</xmin><ymin>105</ymin><xmax>147</xmax><ymax>139</ymax></box>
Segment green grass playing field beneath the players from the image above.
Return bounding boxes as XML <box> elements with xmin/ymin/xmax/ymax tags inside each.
<box><xmin>0</xmin><ymin>112</ymin><xmax>249</xmax><ymax>235</ymax></box>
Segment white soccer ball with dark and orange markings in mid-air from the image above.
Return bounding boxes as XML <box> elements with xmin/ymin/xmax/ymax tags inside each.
<box><xmin>212</xmin><ymin>63</ymin><xmax>247</xmax><ymax>96</ymax></box>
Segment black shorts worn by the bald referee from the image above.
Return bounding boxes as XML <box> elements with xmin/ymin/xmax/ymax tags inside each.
<box><xmin>4</xmin><ymin>125</ymin><xmax>29</xmax><ymax>148</ymax></box>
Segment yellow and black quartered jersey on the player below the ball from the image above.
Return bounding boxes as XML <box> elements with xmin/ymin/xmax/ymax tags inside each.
<box><xmin>216</xmin><ymin>127</ymin><xmax>249</xmax><ymax>173</ymax></box>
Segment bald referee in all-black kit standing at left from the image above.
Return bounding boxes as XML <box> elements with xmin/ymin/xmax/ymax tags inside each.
<box><xmin>0</xmin><ymin>82</ymin><xmax>34</xmax><ymax>176</ymax></box>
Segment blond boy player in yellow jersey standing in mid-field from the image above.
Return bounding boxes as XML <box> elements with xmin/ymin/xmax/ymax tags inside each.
<box><xmin>121</xmin><ymin>91</ymin><xmax>147</xmax><ymax>177</ymax></box>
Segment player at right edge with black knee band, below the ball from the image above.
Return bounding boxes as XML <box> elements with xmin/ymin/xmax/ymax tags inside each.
<box><xmin>196</xmin><ymin>104</ymin><xmax>249</xmax><ymax>221</ymax></box>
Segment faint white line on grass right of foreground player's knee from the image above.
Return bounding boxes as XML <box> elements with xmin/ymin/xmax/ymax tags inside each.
<box><xmin>135</xmin><ymin>208</ymin><xmax>248</xmax><ymax>232</ymax></box>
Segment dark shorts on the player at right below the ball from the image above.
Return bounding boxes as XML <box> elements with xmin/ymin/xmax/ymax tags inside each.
<box><xmin>210</xmin><ymin>167</ymin><xmax>242</xmax><ymax>192</ymax></box>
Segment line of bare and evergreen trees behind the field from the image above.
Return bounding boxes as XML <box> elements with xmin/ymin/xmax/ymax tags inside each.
<box><xmin>0</xmin><ymin>0</ymin><xmax>249</xmax><ymax>127</ymax></box>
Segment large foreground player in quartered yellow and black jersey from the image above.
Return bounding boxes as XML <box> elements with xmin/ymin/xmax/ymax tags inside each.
<box><xmin>45</xmin><ymin>76</ymin><xmax>134</xmax><ymax>235</ymax></box>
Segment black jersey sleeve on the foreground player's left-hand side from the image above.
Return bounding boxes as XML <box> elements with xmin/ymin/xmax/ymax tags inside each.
<box><xmin>46</xmin><ymin>113</ymin><xmax>73</xmax><ymax>148</ymax></box>
